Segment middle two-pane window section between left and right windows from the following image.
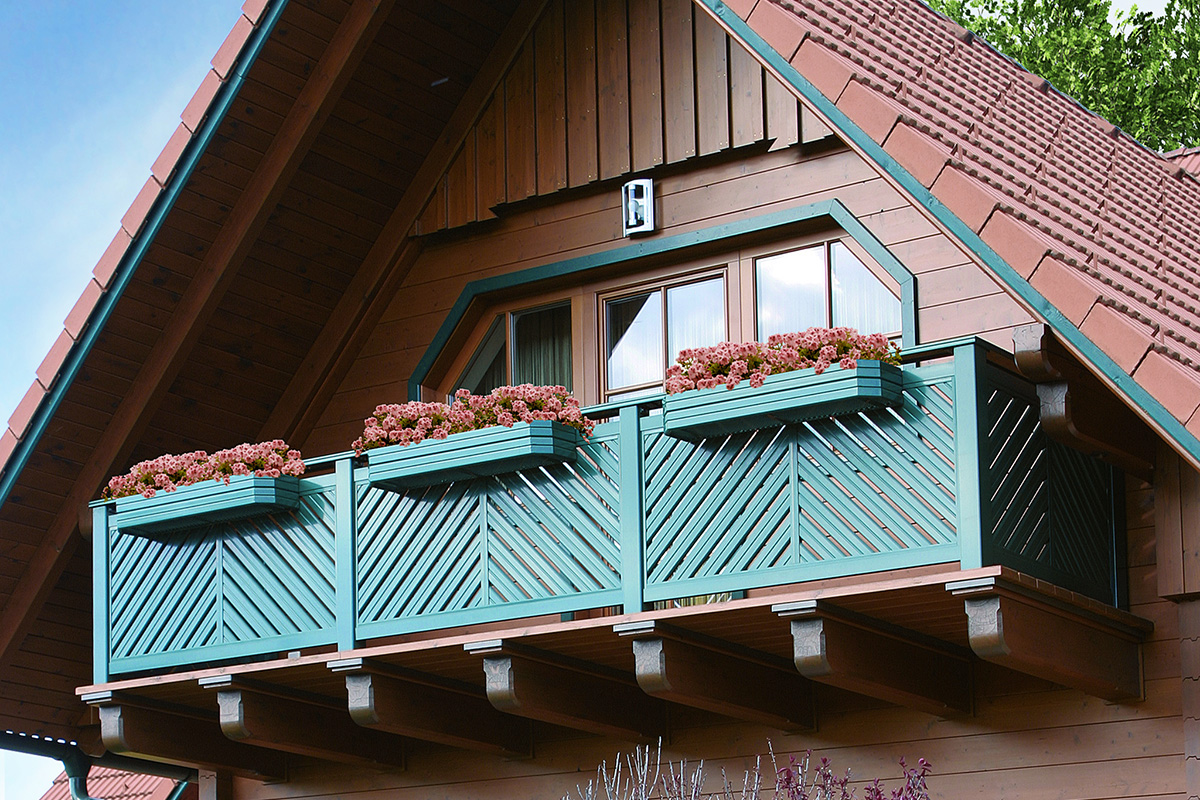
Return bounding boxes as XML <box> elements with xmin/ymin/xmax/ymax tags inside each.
<box><xmin>604</xmin><ymin>276</ymin><xmax>728</xmax><ymax>399</ymax></box>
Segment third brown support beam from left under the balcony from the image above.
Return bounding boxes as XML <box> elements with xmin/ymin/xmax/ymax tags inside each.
<box><xmin>329</xmin><ymin>658</ymin><xmax>533</xmax><ymax>758</ymax></box>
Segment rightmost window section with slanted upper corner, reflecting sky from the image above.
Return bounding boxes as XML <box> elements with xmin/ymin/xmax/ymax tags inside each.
<box><xmin>755</xmin><ymin>241</ymin><xmax>900</xmax><ymax>341</ymax></box>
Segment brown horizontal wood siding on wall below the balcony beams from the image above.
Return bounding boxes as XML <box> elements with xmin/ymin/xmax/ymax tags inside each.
<box><xmin>225</xmin><ymin>481</ymin><xmax>1187</xmax><ymax>800</ymax></box>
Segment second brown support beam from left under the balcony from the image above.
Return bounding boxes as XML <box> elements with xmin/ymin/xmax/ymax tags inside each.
<box><xmin>200</xmin><ymin>675</ymin><xmax>404</xmax><ymax>769</ymax></box>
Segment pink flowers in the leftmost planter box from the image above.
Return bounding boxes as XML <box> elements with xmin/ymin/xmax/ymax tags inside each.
<box><xmin>101</xmin><ymin>439</ymin><xmax>304</xmax><ymax>500</ymax></box>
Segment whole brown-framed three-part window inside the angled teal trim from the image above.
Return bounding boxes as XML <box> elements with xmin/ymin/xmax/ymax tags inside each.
<box><xmin>436</xmin><ymin>235</ymin><xmax>901</xmax><ymax>404</ymax></box>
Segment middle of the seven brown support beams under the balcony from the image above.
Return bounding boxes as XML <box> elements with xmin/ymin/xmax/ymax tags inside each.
<box><xmin>464</xmin><ymin>639</ymin><xmax>666</xmax><ymax>744</ymax></box>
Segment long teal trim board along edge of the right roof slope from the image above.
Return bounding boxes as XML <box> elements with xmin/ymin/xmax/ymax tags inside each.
<box><xmin>696</xmin><ymin>0</ymin><xmax>1200</xmax><ymax>463</ymax></box>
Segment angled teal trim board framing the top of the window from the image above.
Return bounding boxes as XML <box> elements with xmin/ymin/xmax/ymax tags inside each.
<box><xmin>408</xmin><ymin>199</ymin><xmax>917</xmax><ymax>399</ymax></box>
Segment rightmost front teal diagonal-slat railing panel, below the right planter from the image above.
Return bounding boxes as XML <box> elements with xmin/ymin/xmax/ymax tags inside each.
<box><xmin>643</xmin><ymin>367</ymin><xmax>958</xmax><ymax>585</ymax></box>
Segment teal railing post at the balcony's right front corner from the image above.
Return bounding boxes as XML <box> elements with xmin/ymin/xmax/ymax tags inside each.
<box><xmin>954</xmin><ymin>342</ymin><xmax>990</xmax><ymax>570</ymax></box>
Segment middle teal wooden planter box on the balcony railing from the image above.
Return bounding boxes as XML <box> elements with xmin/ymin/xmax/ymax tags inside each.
<box><xmin>367</xmin><ymin>420</ymin><xmax>581</xmax><ymax>492</ymax></box>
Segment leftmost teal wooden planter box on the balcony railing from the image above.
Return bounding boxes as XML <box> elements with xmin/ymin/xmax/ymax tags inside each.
<box><xmin>110</xmin><ymin>475</ymin><xmax>300</xmax><ymax>535</ymax></box>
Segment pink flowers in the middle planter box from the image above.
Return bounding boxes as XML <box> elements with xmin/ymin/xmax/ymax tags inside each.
<box><xmin>352</xmin><ymin>384</ymin><xmax>595</xmax><ymax>456</ymax></box>
